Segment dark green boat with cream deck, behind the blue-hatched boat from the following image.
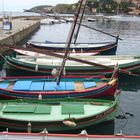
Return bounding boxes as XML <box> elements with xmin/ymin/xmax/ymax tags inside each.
<box><xmin>5</xmin><ymin>55</ymin><xmax>140</xmax><ymax>75</ymax></box>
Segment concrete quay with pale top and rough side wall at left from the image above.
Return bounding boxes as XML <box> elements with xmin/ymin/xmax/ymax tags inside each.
<box><xmin>0</xmin><ymin>18</ymin><xmax>40</xmax><ymax>45</ymax></box>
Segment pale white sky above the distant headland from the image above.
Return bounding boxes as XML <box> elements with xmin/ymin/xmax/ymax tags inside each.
<box><xmin>0</xmin><ymin>0</ymin><xmax>78</xmax><ymax>12</ymax></box>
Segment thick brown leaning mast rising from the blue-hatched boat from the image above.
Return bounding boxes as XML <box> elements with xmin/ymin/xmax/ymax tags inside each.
<box><xmin>56</xmin><ymin>0</ymin><xmax>86</xmax><ymax>85</ymax></box>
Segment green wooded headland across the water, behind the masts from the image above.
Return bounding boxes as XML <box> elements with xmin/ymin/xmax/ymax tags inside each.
<box><xmin>31</xmin><ymin>0</ymin><xmax>133</xmax><ymax>14</ymax></box>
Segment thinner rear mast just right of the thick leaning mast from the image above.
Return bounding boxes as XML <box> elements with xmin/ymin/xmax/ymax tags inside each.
<box><xmin>74</xmin><ymin>0</ymin><xmax>87</xmax><ymax>44</ymax></box>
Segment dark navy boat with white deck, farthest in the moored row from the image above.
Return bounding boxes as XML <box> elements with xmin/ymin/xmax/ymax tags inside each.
<box><xmin>26</xmin><ymin>38</ymin><xmax>118</xmax><ymax>55</ymax></box>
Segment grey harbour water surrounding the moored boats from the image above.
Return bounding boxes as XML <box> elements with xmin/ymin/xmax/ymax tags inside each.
<box><xmin>0</xmin><ymin>16</ymin><xmax>140</xmax><ymax>135</ymax></box>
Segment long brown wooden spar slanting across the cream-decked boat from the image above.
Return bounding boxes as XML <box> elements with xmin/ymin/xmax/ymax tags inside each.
<box><xmin>1</xmin><ymin>45</ymin><xmax>138</xmax><ymax>76</ymax></box>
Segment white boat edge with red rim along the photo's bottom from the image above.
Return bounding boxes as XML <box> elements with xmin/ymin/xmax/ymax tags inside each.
<box><xmin>0</xmin><ymin>131</ymin><xmax>140</xmax><ymax>140</ymax></box>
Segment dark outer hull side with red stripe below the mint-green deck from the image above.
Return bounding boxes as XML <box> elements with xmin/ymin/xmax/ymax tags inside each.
<box><xmin>0</xmin><ymin>107</ymin><xmax>116</xmax><ymax>132</ymax></box>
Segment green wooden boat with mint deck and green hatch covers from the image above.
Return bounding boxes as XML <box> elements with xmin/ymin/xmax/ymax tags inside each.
<box><xmin>0</xmin><ymin>92</ymin><xmax>120</xmax><ymax>132</ymax></box>
